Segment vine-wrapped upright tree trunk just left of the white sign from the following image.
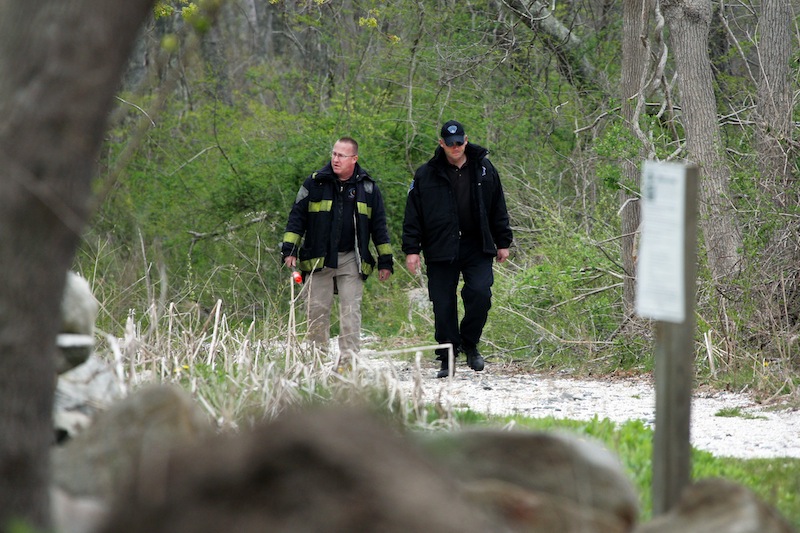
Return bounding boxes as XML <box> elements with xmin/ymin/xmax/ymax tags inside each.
<box><xmin>619</xmin><ymin>0</ymin><xmax>653</xmax><ymax>316</ymax></box>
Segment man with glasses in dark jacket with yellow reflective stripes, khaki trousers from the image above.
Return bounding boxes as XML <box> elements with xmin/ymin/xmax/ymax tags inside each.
<box><xmin>281</xmin><ymin>137</ymin><xmax>393</xmax><ymax>367</ymax></box>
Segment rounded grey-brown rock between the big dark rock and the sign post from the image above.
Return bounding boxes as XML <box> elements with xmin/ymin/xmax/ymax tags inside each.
<box><xmin>421</xmin><ymin>429</ymin><xmax>639</xmax><ymax>532</ymax></box>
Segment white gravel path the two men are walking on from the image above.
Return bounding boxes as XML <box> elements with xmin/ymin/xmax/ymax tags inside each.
<box><xmin>378</xmin><ymin>354</ymin><xmax>800</xmax><ymax>458</ymax></box>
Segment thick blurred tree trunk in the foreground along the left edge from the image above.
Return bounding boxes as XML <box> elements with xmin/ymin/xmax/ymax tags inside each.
<box><xmin>0</xmin><ymin>0</ymin><xmax>151</xmax><ymax>530</ymax></box>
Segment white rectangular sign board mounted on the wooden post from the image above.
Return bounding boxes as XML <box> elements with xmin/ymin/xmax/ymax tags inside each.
<box><xmin>636</xmin><ymin>161</ymin><xmax>686</xmax><ymax>323</ymax></box>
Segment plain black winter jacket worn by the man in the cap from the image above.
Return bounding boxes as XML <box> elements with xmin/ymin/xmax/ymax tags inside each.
<box><xmin>403</xmin><ymin>143</ymin><xmax>512</xmax><ymax>262</ymax></box>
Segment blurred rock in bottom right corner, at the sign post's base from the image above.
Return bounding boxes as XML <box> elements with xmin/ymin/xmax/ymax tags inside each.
<box><xmin>636</xmin><ymin>479</ymin><xmax>795</xmax><ymax>533</ymax></box>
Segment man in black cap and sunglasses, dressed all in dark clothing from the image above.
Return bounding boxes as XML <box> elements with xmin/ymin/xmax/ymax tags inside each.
<box><xmin>403</xmin><ymin>120</ymin><xmax>512</xmax><ymax>378</ymax></box>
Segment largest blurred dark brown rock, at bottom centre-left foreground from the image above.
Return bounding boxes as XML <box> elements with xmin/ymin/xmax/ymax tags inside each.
<box><xmin>97</xmin><ymin>408</ymin><xmax>493</xmax><ymax>533</ymax></box>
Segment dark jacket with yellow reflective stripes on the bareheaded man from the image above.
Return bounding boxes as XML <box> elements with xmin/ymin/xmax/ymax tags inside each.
<box><xmin>281</xmin><ymin>162</ymin><xmax>393</xmax><ymax>279</ymax></box>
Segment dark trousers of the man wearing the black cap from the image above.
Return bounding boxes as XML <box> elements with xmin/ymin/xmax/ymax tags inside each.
<box><xmin>425</xmin><ymin>240</ymin><xmax>494</xmax><ymax>360</ymax></box>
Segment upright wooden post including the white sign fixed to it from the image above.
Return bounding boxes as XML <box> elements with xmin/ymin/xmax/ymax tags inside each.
<box><xmin>637</xmin><ymin>162</ymin><xmax>698</xmax><ymax>516</ymax></box>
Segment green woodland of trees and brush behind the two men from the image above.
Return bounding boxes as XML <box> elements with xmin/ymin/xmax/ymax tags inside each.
<box><xmin>75</xmin><ymin>0</ymin><xmax>800</xmax><ymax>395</ymax></box>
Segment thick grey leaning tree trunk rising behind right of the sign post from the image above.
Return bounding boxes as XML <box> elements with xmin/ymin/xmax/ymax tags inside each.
<box><xmin>662</xmin><ymin>0</ymin><xmax>742</xmax><ymax>283</ymax></box>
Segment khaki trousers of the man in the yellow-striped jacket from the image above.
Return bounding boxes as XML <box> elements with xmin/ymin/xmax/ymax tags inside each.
<box><xmin>303</xmin><ymin>252</ymin><xmax>364</xmax><ymax>364</ymax></box>
